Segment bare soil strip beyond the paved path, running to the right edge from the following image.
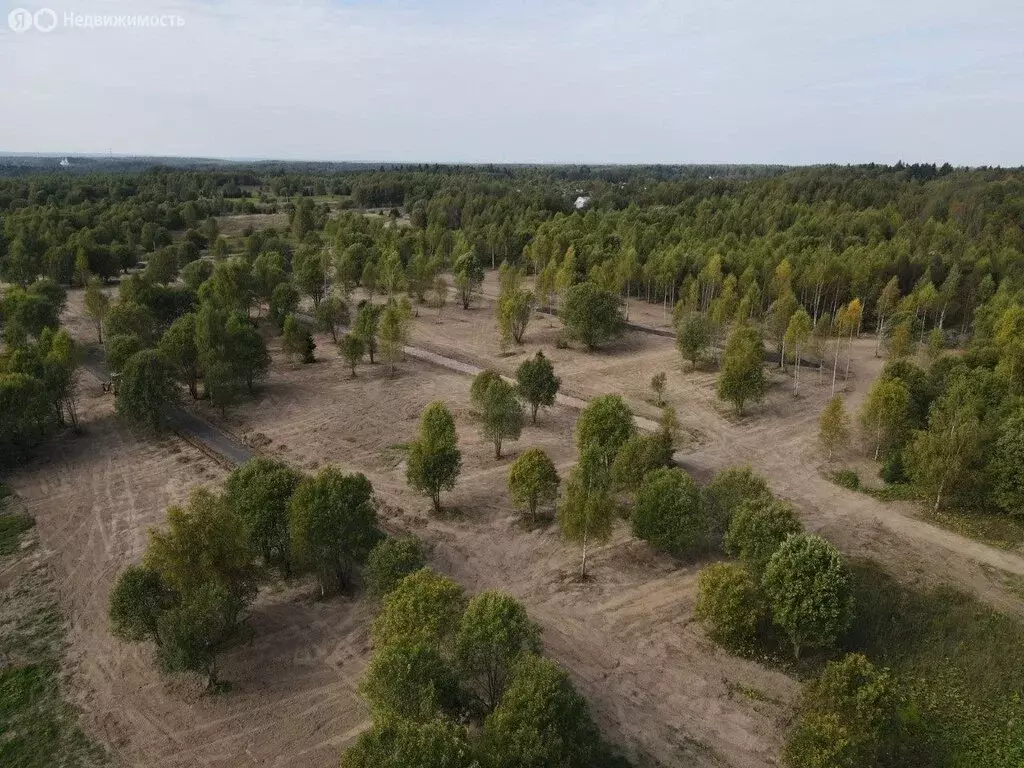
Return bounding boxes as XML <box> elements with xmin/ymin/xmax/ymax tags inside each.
<box><xmin>399</xmin><ymin>296</ymin><xmax>1024</xmax><ymax>613</ymax></box>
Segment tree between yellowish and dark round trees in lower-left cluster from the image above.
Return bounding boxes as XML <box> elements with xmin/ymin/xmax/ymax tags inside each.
<box><xmin>224</xmin><ymin>457</ymin><xmax>302</xmax><ymax>577</ymax></box>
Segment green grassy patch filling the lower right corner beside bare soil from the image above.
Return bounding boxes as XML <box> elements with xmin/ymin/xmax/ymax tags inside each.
<box><xmin>847</xmin><ymin>562</ymin><xmax>1024</xmax><ymax>768</ymax></box>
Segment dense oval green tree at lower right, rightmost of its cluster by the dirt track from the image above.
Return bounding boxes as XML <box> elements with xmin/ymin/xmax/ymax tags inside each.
<box><xmin>763</xmin><ymin>534</ymin><xmax>853</xmax><ymax>658</ymax></box>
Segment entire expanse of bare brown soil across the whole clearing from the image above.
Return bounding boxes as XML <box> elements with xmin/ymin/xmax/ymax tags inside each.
<box><xmin>11</xmin><ymin>284</ymin><xmax>1024</xmax><ymax>768</ymax></box>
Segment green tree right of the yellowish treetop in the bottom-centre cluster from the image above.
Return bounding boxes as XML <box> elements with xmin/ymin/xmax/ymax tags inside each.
<box><xmin>455</xmin><ymin>590</ymin><xmax>541</xmax><ymax>714</ymax></box>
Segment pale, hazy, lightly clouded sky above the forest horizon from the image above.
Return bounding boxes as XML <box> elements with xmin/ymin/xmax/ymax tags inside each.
<box><xmin>0</xmin><ymin>0</ymin><xmax>1024</xmax><ymax>166</ymax></box>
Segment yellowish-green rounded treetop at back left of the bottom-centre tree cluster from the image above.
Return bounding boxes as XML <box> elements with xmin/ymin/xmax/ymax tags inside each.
<box><xmin>371</xmin><ymin>568</ymin><xmax>466</xmax><ymax>648</ymax></box>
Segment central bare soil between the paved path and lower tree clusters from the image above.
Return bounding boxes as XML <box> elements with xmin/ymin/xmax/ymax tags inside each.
<box><xmin>197</xmin><ymin>337</ymin><xmax>797</xmax><ymax>766</ymax></box>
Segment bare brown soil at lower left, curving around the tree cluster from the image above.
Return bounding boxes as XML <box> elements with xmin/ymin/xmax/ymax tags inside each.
<box><xmin>5</xmin><ymin>358</ymin><xmax>370</xmax><ymax>768</ymax></box>
